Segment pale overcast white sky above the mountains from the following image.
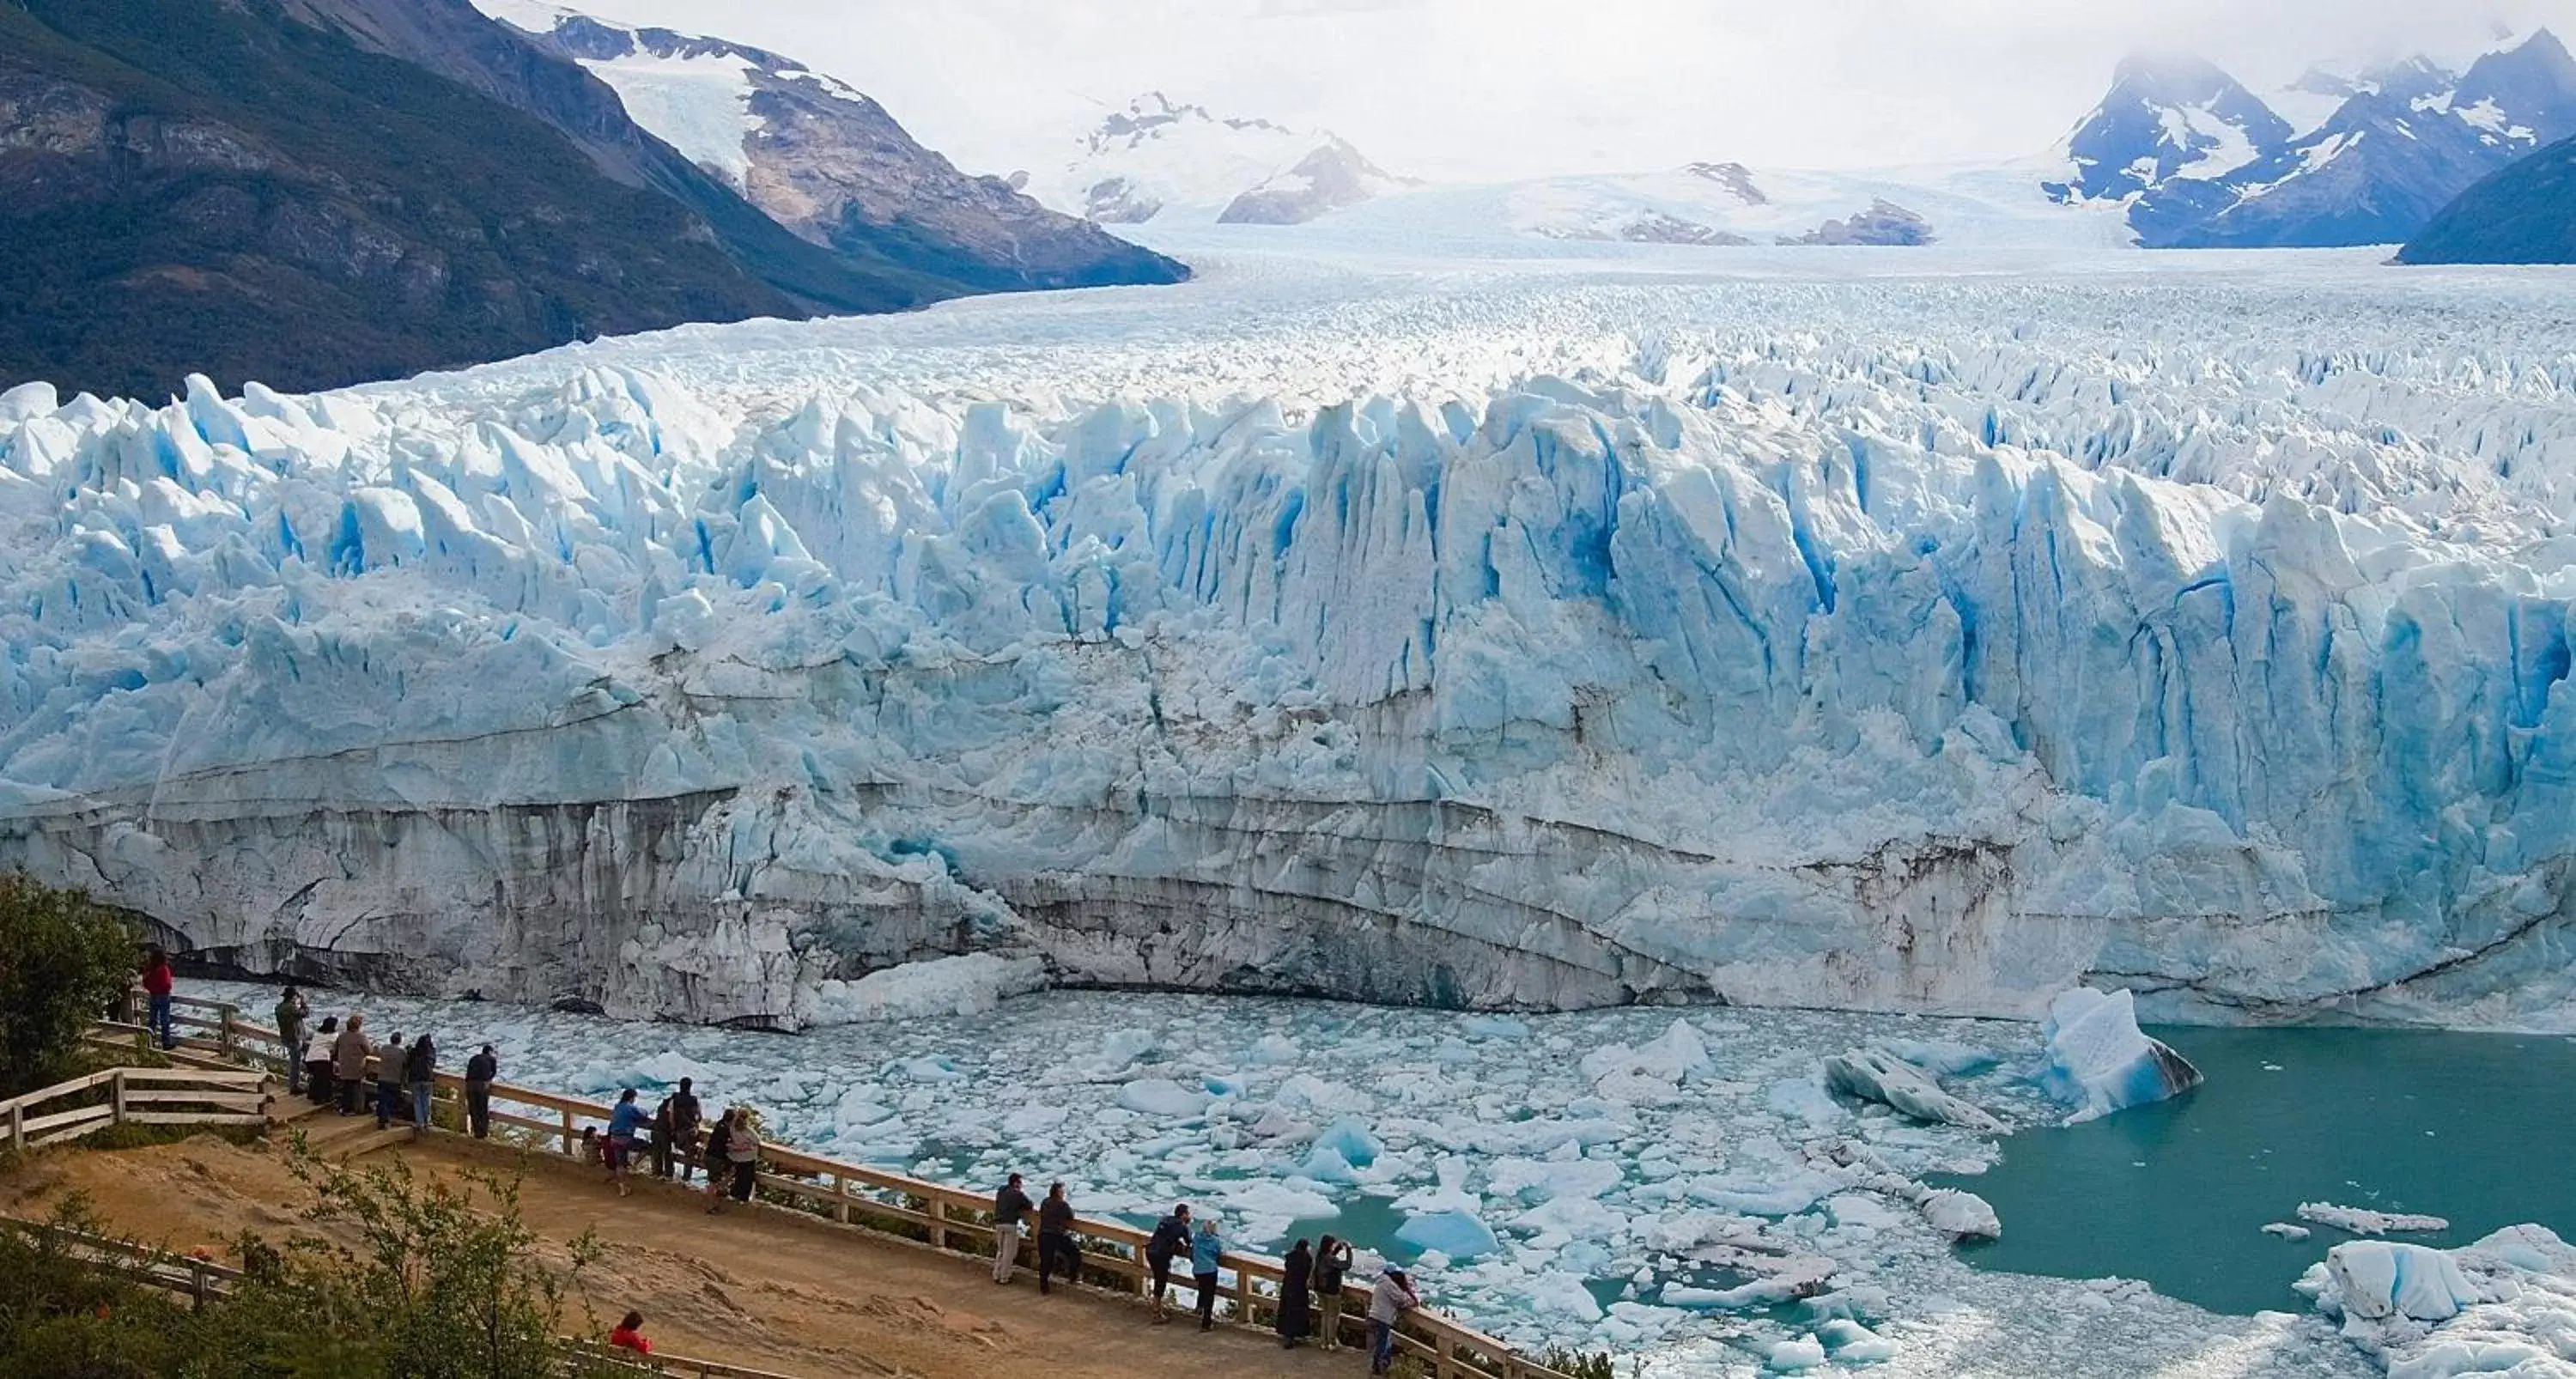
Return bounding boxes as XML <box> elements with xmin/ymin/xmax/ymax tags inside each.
<box><xmin>572</xmin><ymin>0</ymin><xmax>2576</xmax><ymax>180</ymax></box>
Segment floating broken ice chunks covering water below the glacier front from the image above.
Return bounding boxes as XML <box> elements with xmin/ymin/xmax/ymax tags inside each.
<box><xmin>209</xmin><ymin>984</ymin><xmax>2576</xmax><ymax>1379</ymax></box>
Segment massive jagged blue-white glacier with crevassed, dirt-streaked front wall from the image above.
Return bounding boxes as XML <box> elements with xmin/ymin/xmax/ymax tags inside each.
<box><xmin>0</xmin><ymin>273</ymin><xmax>2576</xmax><ymax>1029</ymax></box>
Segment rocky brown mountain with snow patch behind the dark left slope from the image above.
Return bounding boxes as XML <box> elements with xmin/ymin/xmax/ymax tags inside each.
<box><xmin>479</xmin><ymin>0</ymin><xmax>1188</xmax><ymax>289</ymax></box>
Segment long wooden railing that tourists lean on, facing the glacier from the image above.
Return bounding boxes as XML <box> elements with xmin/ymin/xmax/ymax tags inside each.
<box><xmin>141</xmin><ymin>998</ymin><xmax>1569</xmax><ymax>1379</ymax></box>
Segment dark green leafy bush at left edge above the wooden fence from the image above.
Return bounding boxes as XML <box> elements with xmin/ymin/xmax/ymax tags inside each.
<box><xmin>0</xmin><ymin>874</ymin><xmax>134</xmax><ymax>1096</ymax></box>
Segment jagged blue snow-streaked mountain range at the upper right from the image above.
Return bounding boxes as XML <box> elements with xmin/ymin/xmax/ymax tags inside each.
<box><xmin>2045</xmin><ymin>31</ymin><xmax>2576</xmax><ymax>247</ymax></box>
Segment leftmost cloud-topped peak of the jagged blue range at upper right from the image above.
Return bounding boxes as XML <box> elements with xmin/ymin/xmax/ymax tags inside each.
<box><xmin>2048</xmin><ymin>57</ymin><xmax>2293</xmax><ymax>201</ymax></box>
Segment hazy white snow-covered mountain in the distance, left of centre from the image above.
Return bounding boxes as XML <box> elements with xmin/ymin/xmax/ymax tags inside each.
<box><xmin>1033</xmin><ymin>90</ymin><xmax>1406</xmax><ymax>224</ymax></box>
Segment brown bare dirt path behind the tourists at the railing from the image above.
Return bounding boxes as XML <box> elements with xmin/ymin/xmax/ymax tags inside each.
<box><xmin>0</xmin><ymin>1116</ymin><xmax>1368</xmax><ymax>1379</ymax></box>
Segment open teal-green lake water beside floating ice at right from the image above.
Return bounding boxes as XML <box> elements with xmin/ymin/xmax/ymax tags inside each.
<box><xmin>1950</xmin><ymin>1029</ymin><xmax>2576</xmax><ymax>1315</ymax></box>
